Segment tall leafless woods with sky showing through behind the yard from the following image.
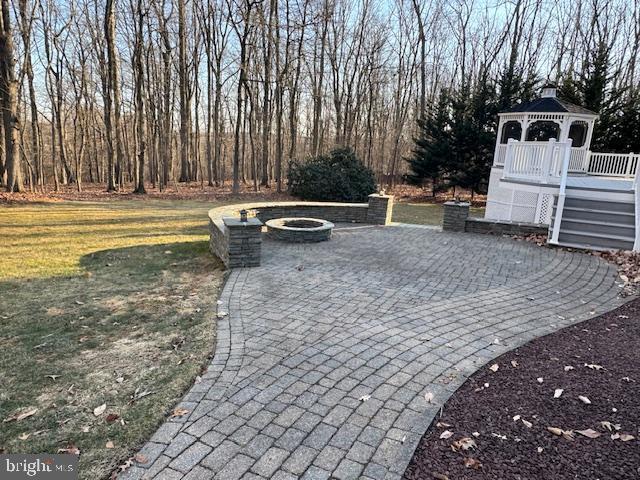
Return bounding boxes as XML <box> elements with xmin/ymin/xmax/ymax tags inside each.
<box><xmin>0</xmin><ymin>0</ymin><xmax>640</xmax><ymax>193</ymax></box>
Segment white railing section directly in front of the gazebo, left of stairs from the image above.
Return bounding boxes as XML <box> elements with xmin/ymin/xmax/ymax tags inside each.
<box><xmin>503</xmin><ymin>140</ymin><xmax>569</xmax><ymax>184</ymax></box>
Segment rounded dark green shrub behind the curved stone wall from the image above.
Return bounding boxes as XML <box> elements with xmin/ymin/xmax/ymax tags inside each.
<box><xmin>288</xmin><ymin>147</ymin><xmax>376</xmax><ymax>202</ymax></box>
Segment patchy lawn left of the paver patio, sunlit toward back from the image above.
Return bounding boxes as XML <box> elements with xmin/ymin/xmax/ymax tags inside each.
<box><xmin>0</xmin><ymin>200</ymin><xmax>222</xmax><ymax>479</ymax></box>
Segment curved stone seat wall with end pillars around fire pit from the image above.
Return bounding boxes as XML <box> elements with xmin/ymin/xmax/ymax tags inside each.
<box><xmin>209</xmin><ymin>193</ymin><xmax>393</xmax><ymax>268</ymax></box>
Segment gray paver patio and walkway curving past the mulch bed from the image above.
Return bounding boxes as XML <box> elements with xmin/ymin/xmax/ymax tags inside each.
<box><xmin>121</xmin><ymin>226</ymin><xmax>623</xmax><ymax>480</ymax></box>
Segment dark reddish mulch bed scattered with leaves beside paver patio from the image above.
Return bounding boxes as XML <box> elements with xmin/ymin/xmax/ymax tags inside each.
<box><xmin>404</xmin><ymin>299</ymin><xmax>640</xmax><ymax>480</ymax></box>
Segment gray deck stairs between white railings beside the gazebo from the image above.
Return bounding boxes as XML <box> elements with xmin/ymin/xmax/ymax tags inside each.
<box><xmin>551</xmin><ymin>195</ymin><xmax>636</xmax><ymax>250</ymax></box>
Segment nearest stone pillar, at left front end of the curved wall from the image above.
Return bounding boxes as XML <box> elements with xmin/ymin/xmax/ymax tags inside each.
<box><xmin>222</xmin><ymin>217</ymin><xmax>262</xmax><ymax>268</ymax></box>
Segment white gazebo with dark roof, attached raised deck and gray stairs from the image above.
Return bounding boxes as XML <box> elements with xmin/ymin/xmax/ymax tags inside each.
<box><xmin>485</xmin><ymin>84</ymin><xmax>640</xmax><ymax>249</ymax></box>
